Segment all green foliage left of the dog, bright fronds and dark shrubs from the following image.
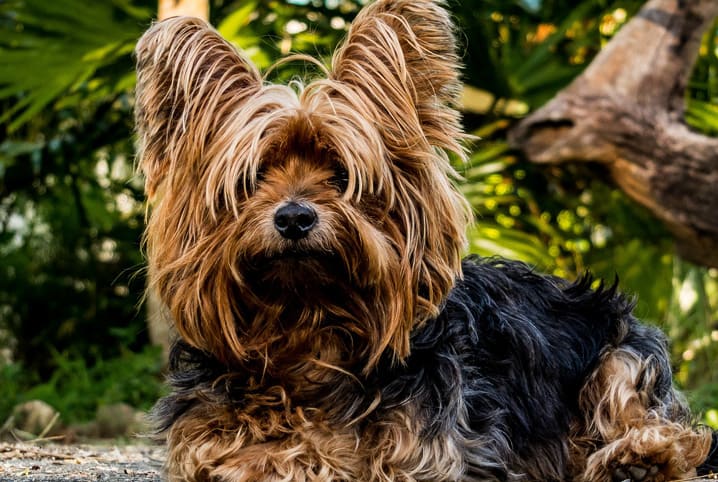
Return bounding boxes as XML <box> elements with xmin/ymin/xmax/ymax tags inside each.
<box><xmin>0</xmin><ymin>0</ymin><xmax>150</xmax><ymax>379</ymax></box>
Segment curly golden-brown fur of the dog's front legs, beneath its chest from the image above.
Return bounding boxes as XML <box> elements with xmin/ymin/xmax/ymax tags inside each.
<box><xmin>168</xmin><ymin>400</ymin><xmax>464</xmax><ymax>482</ymax></box>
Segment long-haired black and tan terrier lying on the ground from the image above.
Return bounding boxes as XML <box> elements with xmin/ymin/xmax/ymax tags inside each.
<box><xmin>136</xmin><ymin>0</ymin><xmax>718</xmax><ymax>482</ymax></box>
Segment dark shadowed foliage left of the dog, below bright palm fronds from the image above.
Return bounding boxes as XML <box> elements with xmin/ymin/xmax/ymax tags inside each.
<box><xmin>0</xmin><ymin>93</ymin><xmax>146</xmax><ymax>376</ymax></box>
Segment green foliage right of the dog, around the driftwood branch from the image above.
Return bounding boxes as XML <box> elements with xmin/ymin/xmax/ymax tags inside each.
<box><xmin>458</xmin><ymin>1</ymin><xmax>718</xmax><ymax>418</ymax></box>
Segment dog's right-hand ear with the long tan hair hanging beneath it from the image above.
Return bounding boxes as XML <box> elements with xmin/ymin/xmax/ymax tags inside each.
<box><xmin>325</xmin><ymin>0</ymin><xmax>471</xmax><ymax>367</ymax></box>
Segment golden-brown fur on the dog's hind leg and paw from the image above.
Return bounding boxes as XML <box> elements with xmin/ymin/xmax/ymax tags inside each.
<box><xmin>572</xmin><ymin>349</ymin><xmax>711</xmax><ymax>482</ymax></box>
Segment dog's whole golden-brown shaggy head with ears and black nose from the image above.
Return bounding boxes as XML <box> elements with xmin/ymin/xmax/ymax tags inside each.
<box><xmin>136</xmin><ymin>0</ymin><xmax>469</xmax><ymax>367</ymax></box>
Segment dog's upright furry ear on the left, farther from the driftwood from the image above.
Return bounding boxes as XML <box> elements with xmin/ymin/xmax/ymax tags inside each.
<box><xmin>135</xmin><ymin>17</ymin><xmax>261</xmax><ymax>197</ymax></box>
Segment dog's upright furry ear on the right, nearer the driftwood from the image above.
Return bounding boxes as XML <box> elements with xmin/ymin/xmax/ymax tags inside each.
<box><xmin>332</xmin><ymin>0</ymin><xmax>463</xmax><ymax>157</ymax></box>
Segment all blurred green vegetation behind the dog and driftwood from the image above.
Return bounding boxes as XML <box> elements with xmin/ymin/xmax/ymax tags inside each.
<box><xmin>0</xmin><ymin>0</ymin><xmax>718</xmax><ymax>438</ymax></box>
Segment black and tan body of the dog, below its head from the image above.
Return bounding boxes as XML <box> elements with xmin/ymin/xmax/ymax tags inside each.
<box><xmin>155</xmin><ymin>259</ymin><xmax>709</xmax><ymax>481</ymax></box>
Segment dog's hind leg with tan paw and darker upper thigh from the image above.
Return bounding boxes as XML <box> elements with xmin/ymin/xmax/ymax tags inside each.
<box><xmin>574</xmin><ymin>324</ymin><xmax>711</xmax><ymax>482</ymax></box>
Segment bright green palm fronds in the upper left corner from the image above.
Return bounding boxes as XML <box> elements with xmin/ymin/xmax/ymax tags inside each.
<box><xmin>0</xmin><ymin>0</ymin><xmax>150</xmax><ymax>132</ymax></box>
